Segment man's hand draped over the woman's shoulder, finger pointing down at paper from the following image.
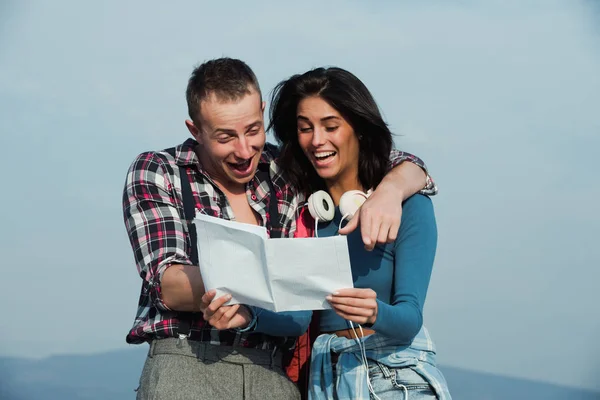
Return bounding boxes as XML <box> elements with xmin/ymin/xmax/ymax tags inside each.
<box><xmin>339</xmin><ymin>181</ymin><xmax>404</xmax><ymax>251</ymax></box>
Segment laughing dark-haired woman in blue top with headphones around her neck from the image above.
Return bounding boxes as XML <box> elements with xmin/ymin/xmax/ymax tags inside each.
<box><xmin>271</xmin><ymin>68</ymin><xmax>450</xmax><ymax>399</ymax></box>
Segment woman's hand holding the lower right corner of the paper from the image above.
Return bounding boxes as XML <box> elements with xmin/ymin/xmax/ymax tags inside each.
<box><xmin>326</xmin><ymin>288</ymin><xmax>377</xmax><ymax>324</ymax></box>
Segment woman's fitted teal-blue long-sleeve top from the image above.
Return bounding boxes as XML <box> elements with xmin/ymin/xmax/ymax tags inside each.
<box><xmin>318</xmin><ymin>194</ymin><xmax>437</xmax><ymax>343</ymax></box>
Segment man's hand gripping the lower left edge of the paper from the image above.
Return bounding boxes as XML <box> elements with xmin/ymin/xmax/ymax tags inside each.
<box><xmin>200</xmin><ymin>289</ymin><xmax>252</xmax><ymax>330</ymax></box>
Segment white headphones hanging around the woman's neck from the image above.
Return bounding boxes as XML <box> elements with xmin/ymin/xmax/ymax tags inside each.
<box><xmin>308</xmin><ymin>190</ymin><xmax>372</xmax><ymax>235</ymax></box>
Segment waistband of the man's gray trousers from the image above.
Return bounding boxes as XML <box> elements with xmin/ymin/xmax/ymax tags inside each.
<box><xmin>148</xmin><ymin>338</ymin><xmax>283</xmax><ymax>368</ymax></box>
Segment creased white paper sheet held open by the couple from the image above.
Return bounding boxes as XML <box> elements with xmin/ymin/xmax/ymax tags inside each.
<box><xmin>194</xmin><ymin>214</ymin><xmax>353</xmax><ymax>312</ymax></box>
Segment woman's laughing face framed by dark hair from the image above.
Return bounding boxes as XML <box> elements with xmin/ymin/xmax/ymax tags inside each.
<box><xmin>296</xmin><ymin>96</ymin><xmax>359</xmax><ymax>182</ymax></box>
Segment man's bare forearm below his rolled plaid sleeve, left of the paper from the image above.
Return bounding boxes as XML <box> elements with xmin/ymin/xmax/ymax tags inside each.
<box><xmin>160</xmin><ymin>264</ymin><xmax>204</xmax><ymax>312</ymax></box>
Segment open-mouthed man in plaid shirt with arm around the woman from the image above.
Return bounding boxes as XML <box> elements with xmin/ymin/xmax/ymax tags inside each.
<box><xmin>123</xmin><ymin>58</ymin><xmax>435</xmax><ymax>399</ymax></box>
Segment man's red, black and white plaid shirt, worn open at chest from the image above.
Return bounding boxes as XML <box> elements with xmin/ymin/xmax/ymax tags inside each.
<box><xmin>123</xmin><ymin>139</ymin><xmax>437</xmax><ymax>349</ymax></box>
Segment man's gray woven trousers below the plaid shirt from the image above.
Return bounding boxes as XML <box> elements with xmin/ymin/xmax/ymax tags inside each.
<box><xmin>137</xmin><ymin>338</ymin><xmax>300</xmax><ymax>400</ymax></box>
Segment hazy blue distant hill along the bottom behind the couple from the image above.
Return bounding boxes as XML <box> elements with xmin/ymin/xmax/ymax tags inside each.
<box><xmin>0</xmin><ymin>346</ymin><xmax>600</xmax><ymax>400</ymax></box>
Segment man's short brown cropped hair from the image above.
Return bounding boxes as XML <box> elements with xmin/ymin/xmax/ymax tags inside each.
<box><xmin>185</xmin><ymin>57</ymin><xmax>262</xmax><ymax>124</ymax></box>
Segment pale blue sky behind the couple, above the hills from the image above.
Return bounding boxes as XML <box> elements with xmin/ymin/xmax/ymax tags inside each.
<box><xmin>0</xmin><ymin>0</ymin><xmax>600</xmax><ymax>391</ymax></box>
